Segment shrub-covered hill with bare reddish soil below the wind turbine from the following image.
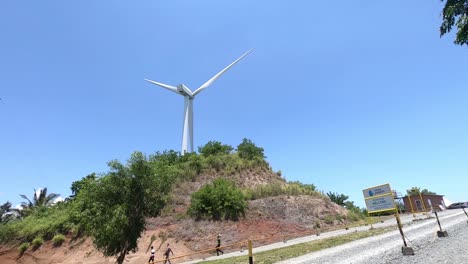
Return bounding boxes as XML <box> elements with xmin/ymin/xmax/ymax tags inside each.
<box><xmin>0</xmin><ymin>139</ymin><xmax>362</xmax><ymax>263</ymax></box>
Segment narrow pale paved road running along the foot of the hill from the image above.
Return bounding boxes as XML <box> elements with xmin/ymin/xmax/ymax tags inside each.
<box><xmin>183</xmin><ymin>209</ymin><xmax>466</xmax><ymax>264</ymax></box>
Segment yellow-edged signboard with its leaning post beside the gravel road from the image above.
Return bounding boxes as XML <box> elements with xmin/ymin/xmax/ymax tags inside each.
<box><xmin>362</xmin><ymin>184</ymin><xmax>414</xmax><ymax>256</ymax></box>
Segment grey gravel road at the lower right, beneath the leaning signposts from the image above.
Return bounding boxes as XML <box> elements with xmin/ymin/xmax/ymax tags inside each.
<box><xmin>279</xmin><ymin>209</ymin><xmax>468</xmax><ymax>264</ymax></box>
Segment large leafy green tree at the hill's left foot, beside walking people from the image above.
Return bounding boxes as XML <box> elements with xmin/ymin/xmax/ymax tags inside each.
<box><xmin>72</xmin><ymin>152</ymin><xmax>171</xmax><ymax>263</ymax></box>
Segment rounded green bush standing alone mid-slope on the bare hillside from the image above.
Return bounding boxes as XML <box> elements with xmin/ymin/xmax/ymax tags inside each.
<box><xmin>189</xmin><ymin>178</ymin><xmax>247</xmax><ymax>220</ymax></box>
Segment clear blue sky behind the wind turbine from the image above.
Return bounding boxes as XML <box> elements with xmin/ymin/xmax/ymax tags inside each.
<box><xmin>0</xmin><ymin>0</ymin><xmax>468</xmax><ymax>208</ymax></box>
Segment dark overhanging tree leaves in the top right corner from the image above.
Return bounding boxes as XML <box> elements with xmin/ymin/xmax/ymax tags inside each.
<box><xmin>440</xmin><ymin>0</ymin><xmax>468</xmax><ymax>46</ymax></box>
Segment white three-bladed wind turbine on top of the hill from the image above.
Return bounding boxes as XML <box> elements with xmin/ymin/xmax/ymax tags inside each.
<box><xmin>145</xmin><ymin>49</ymin><xmax>253</xmax><ymax>154</ymax></box>
